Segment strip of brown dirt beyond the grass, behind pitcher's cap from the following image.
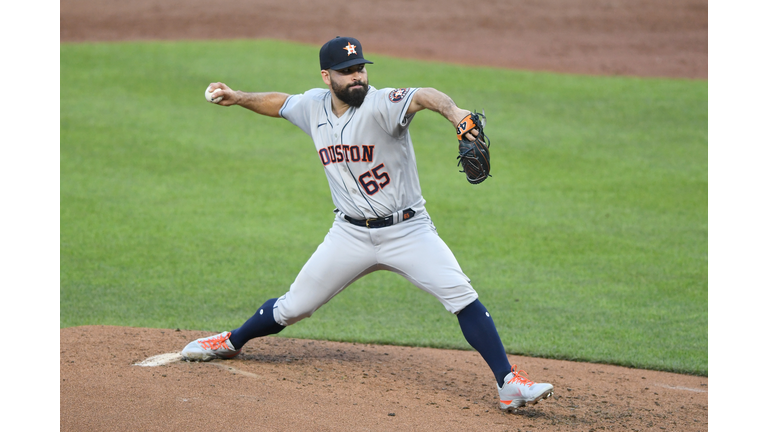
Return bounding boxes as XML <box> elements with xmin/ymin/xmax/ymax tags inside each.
<box><xmin>61</xmin><ymin>0</ymin><xmax>708</xmax><ymax>79</ymax></box>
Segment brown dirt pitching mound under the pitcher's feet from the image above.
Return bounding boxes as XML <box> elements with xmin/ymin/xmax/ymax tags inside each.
<box><xmin>60</xmin><ymin>326</ymin><xmax>708</xmax><ymax>432</ymax></box>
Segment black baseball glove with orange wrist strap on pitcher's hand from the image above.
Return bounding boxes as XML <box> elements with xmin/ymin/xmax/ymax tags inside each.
<box><xmin>456</xmin><ymin>112</ymin><xmax>491</xmax><ymax>184</ymax></box>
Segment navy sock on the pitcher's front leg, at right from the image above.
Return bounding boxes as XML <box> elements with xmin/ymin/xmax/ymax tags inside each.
<box><xmin>457</xmin><ymin>300</ymin><xmax>512</xmax><ymax>387</ymax></box>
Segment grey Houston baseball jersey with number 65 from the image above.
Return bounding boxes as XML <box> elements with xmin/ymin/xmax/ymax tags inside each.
<box><xmin>280</xmin><ymin>86</ymin><xmax>424</xmax><ymax>219</ymax></box>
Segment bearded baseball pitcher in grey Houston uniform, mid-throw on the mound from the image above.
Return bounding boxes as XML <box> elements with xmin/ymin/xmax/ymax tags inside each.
<box><xmin>182</xmin><ymin>37</ymin><xmax>553</xmax><ymax>410</ymax></box>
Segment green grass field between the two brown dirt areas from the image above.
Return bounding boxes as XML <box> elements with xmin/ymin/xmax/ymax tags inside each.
<box><xmin>60</xmin><ymin>41</ymin><xmax>708</xmax><ymax>375</ymax></box>
